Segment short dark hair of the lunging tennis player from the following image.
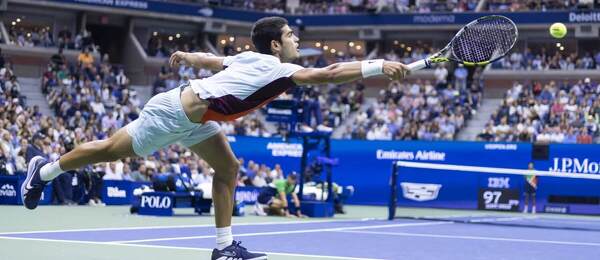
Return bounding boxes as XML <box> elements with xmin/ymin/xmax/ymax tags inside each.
<box><xmin>250</xmin><ymin>16</ymin><xmax>288</xmax><ymax>54</ymax></box>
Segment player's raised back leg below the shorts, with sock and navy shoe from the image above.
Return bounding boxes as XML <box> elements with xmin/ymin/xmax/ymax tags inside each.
<box><xmin>21</xmin><ymin>128</ymin><xmax>135</xmax><ymax>209</ymax></box>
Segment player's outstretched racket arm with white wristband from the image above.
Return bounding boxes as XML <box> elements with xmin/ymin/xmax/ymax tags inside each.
<box><xmin>292</xmin><ymin>60</ymin><xmax>408</xmax><ymax>85</ymax></box>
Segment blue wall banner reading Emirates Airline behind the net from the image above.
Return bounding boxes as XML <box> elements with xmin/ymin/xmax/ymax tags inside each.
<box><xmin>332</xmin><ymin>140</ymin><xmax>531</xmax><ymax>205</ymax></box>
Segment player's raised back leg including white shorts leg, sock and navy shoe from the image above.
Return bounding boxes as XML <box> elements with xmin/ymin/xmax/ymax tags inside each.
<box><xmin>21</xmin><ymin>88</ymin><xmax>189</xmax><ymax>209</ymax></box>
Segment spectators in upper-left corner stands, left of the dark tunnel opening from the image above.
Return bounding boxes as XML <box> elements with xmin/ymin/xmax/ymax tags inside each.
<box><xmin>7</xmin><ymin>26</ymin><xmax>97</xmax><ymax>50</ymax></box>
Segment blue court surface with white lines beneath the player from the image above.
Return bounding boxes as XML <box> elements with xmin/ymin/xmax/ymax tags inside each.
<box><xmin>0</xmin><ymin>208</ymin><xmax>600</xmax><ymax>259</ymax></box>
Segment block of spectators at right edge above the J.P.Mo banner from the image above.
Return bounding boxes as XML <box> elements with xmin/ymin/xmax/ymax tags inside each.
<box><xmin>478</xmin><ymin>78</ymin><xmax>600</xmax><ymax>144</ymax></box>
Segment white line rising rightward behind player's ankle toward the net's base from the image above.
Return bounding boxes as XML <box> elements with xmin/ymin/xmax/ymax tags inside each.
<box><xmin>111</xmin><ymin>221</ymin><xmax>453</xmax><ymax>244</ymax></box>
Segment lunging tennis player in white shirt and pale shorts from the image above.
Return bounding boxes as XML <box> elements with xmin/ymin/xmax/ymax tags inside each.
<box><xmin>21</xmin><ymin>17</ymin><xmax>408</xmax><ymax>260</ymax></box>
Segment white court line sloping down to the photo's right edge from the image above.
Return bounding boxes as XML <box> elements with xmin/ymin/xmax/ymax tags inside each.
<box><xmin>337</xmin><ymin>230</ymin><xmax>600</xmax><ymax>246</ymax></box>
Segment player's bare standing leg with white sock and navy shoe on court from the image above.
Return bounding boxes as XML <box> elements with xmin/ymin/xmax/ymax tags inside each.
<box><xmin>188</xmin><ymin>131</ymin><xmax>267</xmax><ymax>260</ymax></box>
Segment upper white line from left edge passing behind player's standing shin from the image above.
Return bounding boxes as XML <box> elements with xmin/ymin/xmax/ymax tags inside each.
<box><xmin>0</xmin><ymin>219</ymin><xmax>383</xmax><ymax>236</ymax></box>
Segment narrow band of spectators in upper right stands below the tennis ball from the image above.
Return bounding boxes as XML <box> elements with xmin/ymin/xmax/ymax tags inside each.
<box><xmin>491</xmin><ymin>48</ymin><xmax>600</xmax><ymax>70</ymax></box>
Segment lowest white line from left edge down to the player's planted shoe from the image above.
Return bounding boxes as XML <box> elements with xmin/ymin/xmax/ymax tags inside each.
<box><xmin>0</xmin><ymin>236</ymin><xmax>383</xmax><ymax>260</ymax></box>
